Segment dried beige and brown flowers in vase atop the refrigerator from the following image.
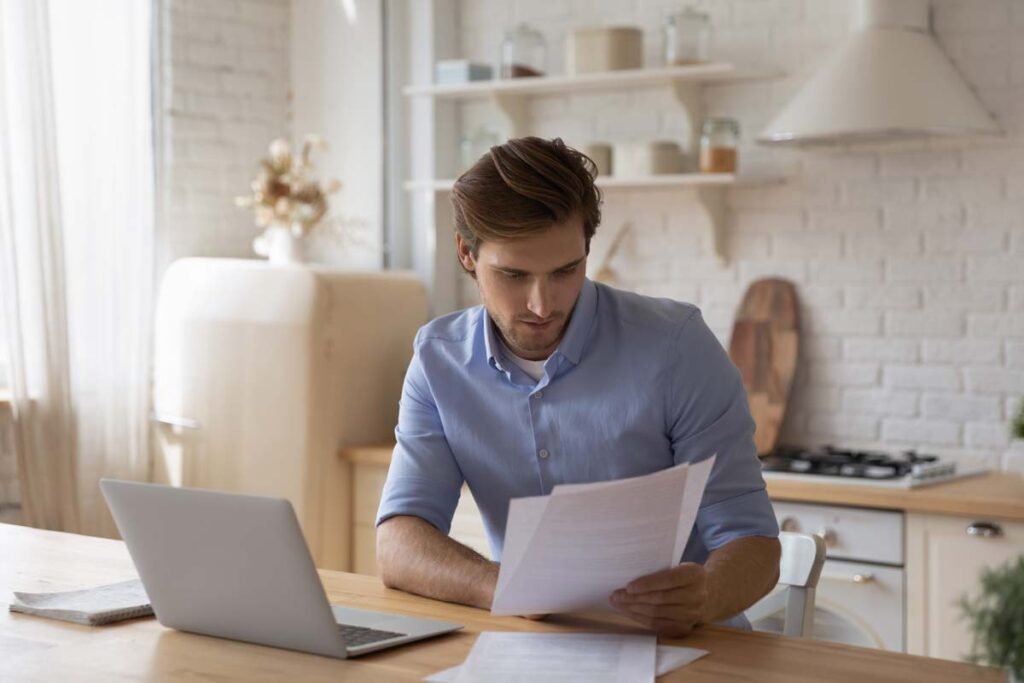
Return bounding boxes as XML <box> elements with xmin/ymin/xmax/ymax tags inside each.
<box><xmin>234</xmin><ymin>135</ymin><xmax>341</xmax><ymax>237</ymax></box>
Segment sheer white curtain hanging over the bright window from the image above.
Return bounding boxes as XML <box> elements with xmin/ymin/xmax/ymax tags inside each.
<box><xmin>0</xmin><ymin>0</ymin><xmax>155</xmax><ymax>536</ymax></box>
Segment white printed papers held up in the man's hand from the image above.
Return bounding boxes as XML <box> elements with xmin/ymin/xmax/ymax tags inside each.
<box><xmin>490</xmin><ymin>456</ymin><xmax>715</xmax><ymax>615</ymax></box>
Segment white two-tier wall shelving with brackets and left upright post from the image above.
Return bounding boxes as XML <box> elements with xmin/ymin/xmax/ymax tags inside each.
<box><xmin>400</xmin><ymin>43</ymin><xmax>783</xmax><ymax>312</ymax></box>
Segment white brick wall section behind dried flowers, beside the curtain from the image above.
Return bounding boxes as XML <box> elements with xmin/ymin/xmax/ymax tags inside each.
<box><xmin>157</xmin><ymin>0</ymin><xmax>291</xmax><ymax>272</ymax></box>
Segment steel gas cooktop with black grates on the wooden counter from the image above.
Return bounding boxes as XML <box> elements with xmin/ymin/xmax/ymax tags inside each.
<box><xmin>761</xmin><ymin>445</ymin><xmax>984</xmax><ymax>488</ymax></box>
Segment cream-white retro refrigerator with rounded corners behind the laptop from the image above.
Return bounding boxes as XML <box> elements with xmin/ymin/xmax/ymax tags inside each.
<box><xmin>153</xmin><ymin>258</ymin><xmax>427</xmax><ymax>570</ymax></box>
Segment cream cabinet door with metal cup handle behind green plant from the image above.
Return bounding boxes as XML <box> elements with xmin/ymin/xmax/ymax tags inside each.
<box><xmin>906</xmin><ymin>513</ymin><xmax>1024</xmax><ymax>659</ymax></box>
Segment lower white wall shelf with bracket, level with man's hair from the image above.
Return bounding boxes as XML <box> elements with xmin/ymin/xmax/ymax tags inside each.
<box><xmin>404</xmin><ymin>173</ymin><xmax>782</xmax><ymax>264</ymax></box>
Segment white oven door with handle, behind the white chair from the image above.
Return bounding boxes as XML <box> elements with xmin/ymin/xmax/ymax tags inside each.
<box><xmin>754</xmin><ymin>559</ymin><xmax>903</xmax><ymax>652</ymax></box>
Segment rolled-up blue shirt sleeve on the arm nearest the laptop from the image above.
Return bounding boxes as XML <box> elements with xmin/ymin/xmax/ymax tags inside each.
<box><xmin>377</xmin><ymin>333</ymin><xmax>463</xmax><ymax>533</ymax></box>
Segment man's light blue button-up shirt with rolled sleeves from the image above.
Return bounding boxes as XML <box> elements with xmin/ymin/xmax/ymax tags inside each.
<box><xmin>377</xmin><ymin>280</ymin><xmax>778</xmax><ymax>562</ymax></box>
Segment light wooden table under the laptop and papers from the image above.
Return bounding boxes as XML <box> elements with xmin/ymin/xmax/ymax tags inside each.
<box><xmin>0</xmin><ymin>524</ymin><xmax>1007</xmax><ymax>683</ymax></box>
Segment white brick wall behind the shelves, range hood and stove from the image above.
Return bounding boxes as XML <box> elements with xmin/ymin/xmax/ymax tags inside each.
<box><xmin>460</xmin><ymin>0</ymin><xmax>1024</xmax><ymax>469</ymax></box>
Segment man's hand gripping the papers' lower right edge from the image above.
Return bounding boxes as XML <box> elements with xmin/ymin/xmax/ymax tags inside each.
<box><xmin>609</xmin><ymin>562</ymin><xmax>709</xmax><ymax>638</ymax></box>
